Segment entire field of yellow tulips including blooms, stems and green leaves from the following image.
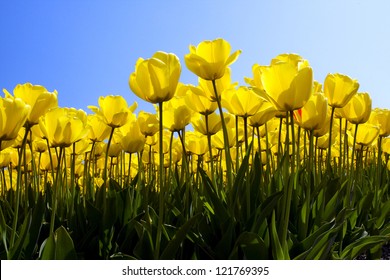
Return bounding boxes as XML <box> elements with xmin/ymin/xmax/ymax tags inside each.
<box><xmin>0</xmin><ymin>39</ymin><xmax>390</xmax><ymax>260</ymax></box>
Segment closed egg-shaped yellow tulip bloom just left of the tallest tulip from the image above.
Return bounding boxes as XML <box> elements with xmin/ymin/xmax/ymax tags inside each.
<box><xmin>129</xmin><ymin>52</ymin><xmax>181</xmax><ymax>103</ymax></box>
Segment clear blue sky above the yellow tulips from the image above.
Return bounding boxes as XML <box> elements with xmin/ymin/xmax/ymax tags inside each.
<box><xmin>0</xmin><ymin>0</ymin><xmax>390</xmax><ymax>112</ymax></box>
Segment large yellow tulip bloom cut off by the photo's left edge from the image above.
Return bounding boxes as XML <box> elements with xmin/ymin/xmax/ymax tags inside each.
<box><xmin>0</xmin><ymin>97</ymin><xmax>31</xmax><ymax>143</ymax></box>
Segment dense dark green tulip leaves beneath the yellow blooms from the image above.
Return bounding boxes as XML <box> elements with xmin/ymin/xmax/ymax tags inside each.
<box><xmin>0</xmin><ymin>149</ymin><xmax>390</xmax><ymax>260</ymax></box>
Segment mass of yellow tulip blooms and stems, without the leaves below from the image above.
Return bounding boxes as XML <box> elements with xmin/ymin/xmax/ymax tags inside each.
<box><xmin>0</xmin><ymin>39</ymin><xmax>390</xmax><ymax>258</ymax></box>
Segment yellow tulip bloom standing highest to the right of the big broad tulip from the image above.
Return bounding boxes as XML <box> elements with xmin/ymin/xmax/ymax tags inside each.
<box><xmin>324</xmin><ymin>73</ymin><xmax>359</xmax><ymax>108</ymax></box>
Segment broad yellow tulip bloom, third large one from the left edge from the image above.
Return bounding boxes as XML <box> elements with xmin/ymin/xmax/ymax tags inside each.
<box><xmin>39</xmin><ymin>108</ymin><xmax>88</xmax><ymax>147</ymax></box>
